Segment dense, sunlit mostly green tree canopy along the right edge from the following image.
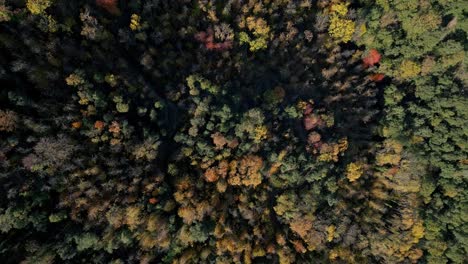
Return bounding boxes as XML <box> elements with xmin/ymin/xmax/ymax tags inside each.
<box><xmin>362</xmin><ymin>0</ymin><xmax>468</xmax><ymax>263</ymax></box>
